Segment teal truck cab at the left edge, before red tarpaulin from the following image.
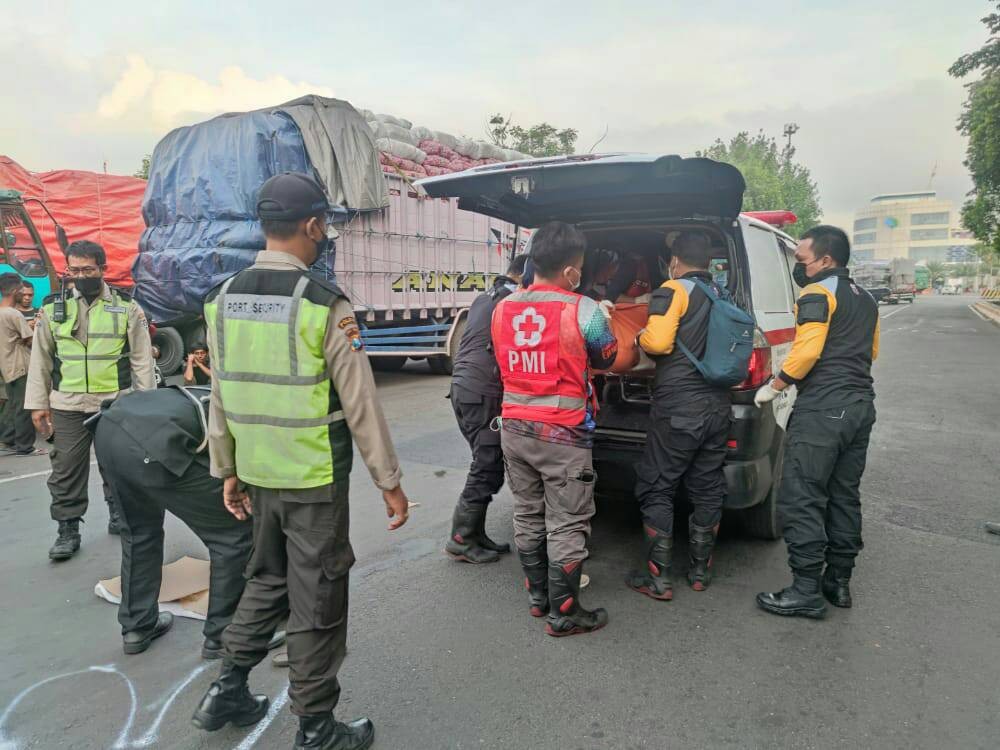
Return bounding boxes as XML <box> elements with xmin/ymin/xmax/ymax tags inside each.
<box><xmin>0</xmin><ymin>189</ymin><xmax>66</xmax><ymax>307</ymax></box>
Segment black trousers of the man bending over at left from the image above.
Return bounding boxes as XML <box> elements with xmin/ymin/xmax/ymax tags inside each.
<box><xmin>94</xmin><ymin>419</ymin><xmax>252</xmax><ymax>639</ymax></box>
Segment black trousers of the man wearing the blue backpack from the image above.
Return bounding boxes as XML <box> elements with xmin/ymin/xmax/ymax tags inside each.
<box><xmin>635</xmin><ymin>398</ymin><xmax>731</xmax><ymax>534</ymax></box>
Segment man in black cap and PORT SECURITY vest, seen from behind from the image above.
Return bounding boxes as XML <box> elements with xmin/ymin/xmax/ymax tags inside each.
<box><xmin>193</xmin><ymin>173</ymin><xmax>408</xmax><ymax>749</ymax></box>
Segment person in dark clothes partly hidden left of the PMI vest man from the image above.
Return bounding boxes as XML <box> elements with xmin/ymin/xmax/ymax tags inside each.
<box><xmin>445</xmin><ymin>255</ymin><xmax>528</xmax><ymax>563</ymax></box>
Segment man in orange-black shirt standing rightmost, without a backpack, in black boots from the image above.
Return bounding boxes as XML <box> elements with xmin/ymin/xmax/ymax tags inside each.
<box><xmin>754</xmin><ymin>226</ymin><xmax>879</xmax><ymax>617</ymax></box>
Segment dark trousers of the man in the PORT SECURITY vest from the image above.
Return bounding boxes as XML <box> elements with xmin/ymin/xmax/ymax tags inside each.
<box><xmin>222</xmin><ymin>480</ymin><xmax>354</xmax><ymax>716</ymax></box>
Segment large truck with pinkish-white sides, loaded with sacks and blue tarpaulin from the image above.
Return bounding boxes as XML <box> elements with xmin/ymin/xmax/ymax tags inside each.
<box><xmin>132</xmin><ymin>97</ymin><xmax>528</xmax><ymax>374</ymax></box>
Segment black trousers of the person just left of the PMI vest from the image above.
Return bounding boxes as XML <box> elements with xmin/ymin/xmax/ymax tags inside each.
<box><xmin>449</xmin><ymin>386</ymin><xmax>503</xmax><ymax>505</ymax></box>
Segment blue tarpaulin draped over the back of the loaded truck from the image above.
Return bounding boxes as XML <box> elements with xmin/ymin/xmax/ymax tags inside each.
<box><xmin>132</xmin><ymin>110</ymin><xmax>352</xmax><ymax>324</ymax></box>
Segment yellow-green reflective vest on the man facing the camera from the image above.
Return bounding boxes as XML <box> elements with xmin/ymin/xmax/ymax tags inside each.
<box><xmin>42</xmin><ymin>289</ymin><xmax>132</xmax><ymax>393</ymax></box>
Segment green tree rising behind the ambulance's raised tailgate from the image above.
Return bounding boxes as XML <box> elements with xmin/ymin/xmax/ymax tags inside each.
<box><xmin>697</xmin><ymin>131</ymin><xmax>821</xmax><ymax>237</ymax></box>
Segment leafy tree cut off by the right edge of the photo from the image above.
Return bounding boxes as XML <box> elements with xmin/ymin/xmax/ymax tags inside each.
<box><xmin>948</xmin><ymin>3</ymin><xmax>1000</xmax><ymax>256</ymax></box>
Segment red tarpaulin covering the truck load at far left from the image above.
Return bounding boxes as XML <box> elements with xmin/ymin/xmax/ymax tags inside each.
<box><xmin>0</xmin><ymin>156</ymin><xmax>146</xmax><ymax>286</ymax></box>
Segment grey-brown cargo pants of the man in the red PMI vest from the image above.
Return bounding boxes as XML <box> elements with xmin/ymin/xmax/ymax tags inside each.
<box><xmin>501</xmin><ymin>430</ymin><xmax>597</xmax><ymax>564</ymax></box>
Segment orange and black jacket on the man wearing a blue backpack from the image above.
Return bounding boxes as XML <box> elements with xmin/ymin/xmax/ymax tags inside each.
<box><xmin>639</xmin><ymin>271</ymin><xmax>729</xmax><ymax>405</ymax></box>
